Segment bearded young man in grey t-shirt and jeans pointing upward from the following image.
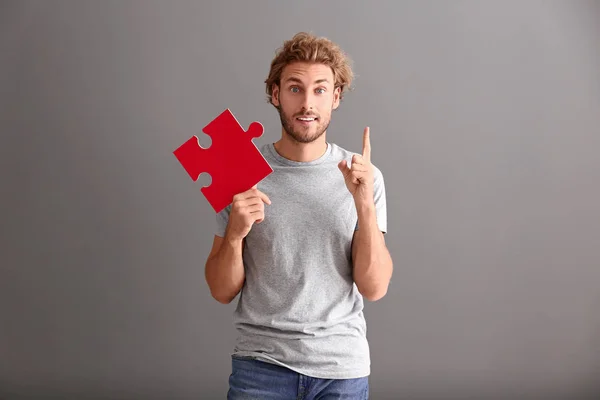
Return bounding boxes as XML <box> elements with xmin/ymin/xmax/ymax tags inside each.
<box><xmin>206</xmin><ymin>33</ymin><xmax>392</xmax><ymax>400</ymax></box>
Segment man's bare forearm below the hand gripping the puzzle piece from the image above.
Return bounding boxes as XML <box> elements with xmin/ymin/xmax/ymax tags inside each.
<box><xmin>206</xmin><ymin>235</ymin><xmax>245</xmax><ymax>304</ymax></box>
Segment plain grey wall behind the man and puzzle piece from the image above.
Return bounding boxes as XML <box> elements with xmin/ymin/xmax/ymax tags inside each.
<box><xmin>0</xmin><ymin>1</ymin><xmax>600</xmax><ymax>399</ymax></box>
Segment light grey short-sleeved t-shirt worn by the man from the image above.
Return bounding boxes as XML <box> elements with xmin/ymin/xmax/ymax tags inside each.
<box><xmin>216</xmin><ymin>143</ymin><xmax>387</xmax><ymax>379</ymax></box>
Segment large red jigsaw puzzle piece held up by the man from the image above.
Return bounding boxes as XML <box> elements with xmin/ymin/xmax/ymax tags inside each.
<box><xmin>173</xmin><ymin>109</ymin><xmax>273</xmax><ymax>213</ymax></box>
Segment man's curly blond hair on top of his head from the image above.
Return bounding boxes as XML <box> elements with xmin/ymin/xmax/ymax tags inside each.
<box><xmin>265</xmin><ymin>32</ymin><xmax>354</xmax><ymax>104</ymax></box>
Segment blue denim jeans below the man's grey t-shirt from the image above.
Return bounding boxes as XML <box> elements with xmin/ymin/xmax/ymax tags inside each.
<box><xmin>227</xmin><ymin>357</ymin><xmax>369</xmax><ymax>400</ymax></box>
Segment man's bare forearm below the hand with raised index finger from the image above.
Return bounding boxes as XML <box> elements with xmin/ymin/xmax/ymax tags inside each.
<box><xmin>352</xmin><ymin>206</ymin><xmax>393</xmax><ymax>301</ymax></box>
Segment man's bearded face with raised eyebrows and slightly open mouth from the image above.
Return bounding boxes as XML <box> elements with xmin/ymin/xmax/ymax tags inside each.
<box><xmin>273</xmin><ymin>62</ymin><xmax>339</xmax><ymax>143</ymax></box>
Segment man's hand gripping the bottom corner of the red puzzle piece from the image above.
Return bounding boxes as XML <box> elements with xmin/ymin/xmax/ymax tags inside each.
<box><xmin>227</xmin><ymin>185</ymin><xmax>271</xmax><ymax>241</ymax></box>
